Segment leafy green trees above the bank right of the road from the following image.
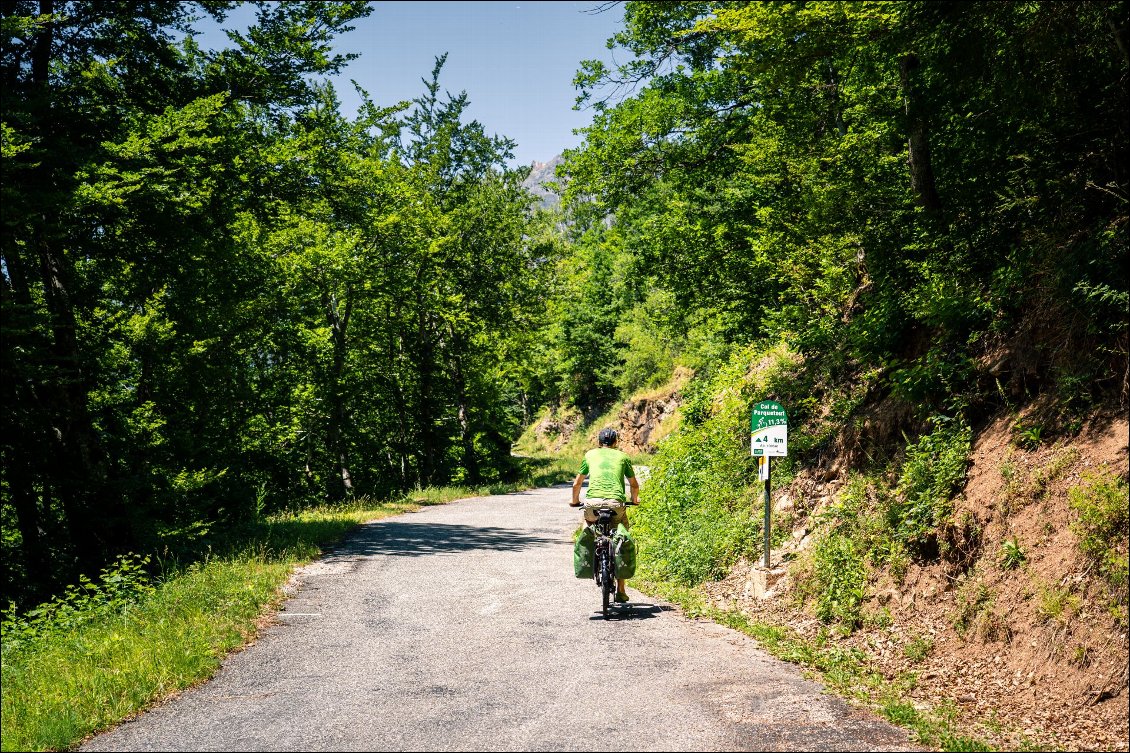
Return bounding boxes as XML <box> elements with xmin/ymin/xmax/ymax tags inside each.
<box><xmin>559</xmin><ymin>2</ymin><xmax>1130</xmax><ymax>497</ymax></box>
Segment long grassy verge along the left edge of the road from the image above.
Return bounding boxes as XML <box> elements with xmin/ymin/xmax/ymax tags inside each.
<box><xmin>0</xmin><ymin>460</ymin><xmax>574</xmax><ymax>751</ymax></box>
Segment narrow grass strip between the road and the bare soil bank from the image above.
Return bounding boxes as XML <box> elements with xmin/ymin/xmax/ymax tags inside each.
<box><xmin>632</xmin><ymin>580</ymin><xmax>992</xmax><ymax>751</ymax></box>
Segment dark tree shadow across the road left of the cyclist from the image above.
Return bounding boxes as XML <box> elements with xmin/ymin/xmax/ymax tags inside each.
<box><xmin>333</xmin><ymin>520</ymin><xmax>560</xmax><ymax>556</ymax></box>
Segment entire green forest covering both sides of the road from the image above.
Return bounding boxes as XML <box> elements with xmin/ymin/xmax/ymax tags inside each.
<box><xmin>0</xmin><ymin>0</ymin><xmax>1130</xmax><ymax>619</ymax></box>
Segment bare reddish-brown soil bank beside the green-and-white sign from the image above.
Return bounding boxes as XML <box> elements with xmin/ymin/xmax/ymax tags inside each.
<box><xmin>703</xmin><ymin>415</ymin><xmax>1130</xmax><ymax>751</ymax></box>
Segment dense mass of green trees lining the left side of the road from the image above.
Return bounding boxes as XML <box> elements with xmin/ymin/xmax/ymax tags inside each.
<box><xmin>0</xmin><ymin>2</ymin><xmax>555</xmax><ymax>605</ymax></box>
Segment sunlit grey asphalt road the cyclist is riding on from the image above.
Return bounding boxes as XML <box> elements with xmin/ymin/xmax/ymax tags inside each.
<box><xmin>80</xmin><ymin>486</ymin><xmax>911</xmax><ymax>751</ymax></box>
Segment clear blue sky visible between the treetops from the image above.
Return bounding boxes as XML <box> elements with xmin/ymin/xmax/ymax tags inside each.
<box><xmin>189</xmin><ymin>0</ymin><xmax>624</xmax><ymax>165</ymax></box>
